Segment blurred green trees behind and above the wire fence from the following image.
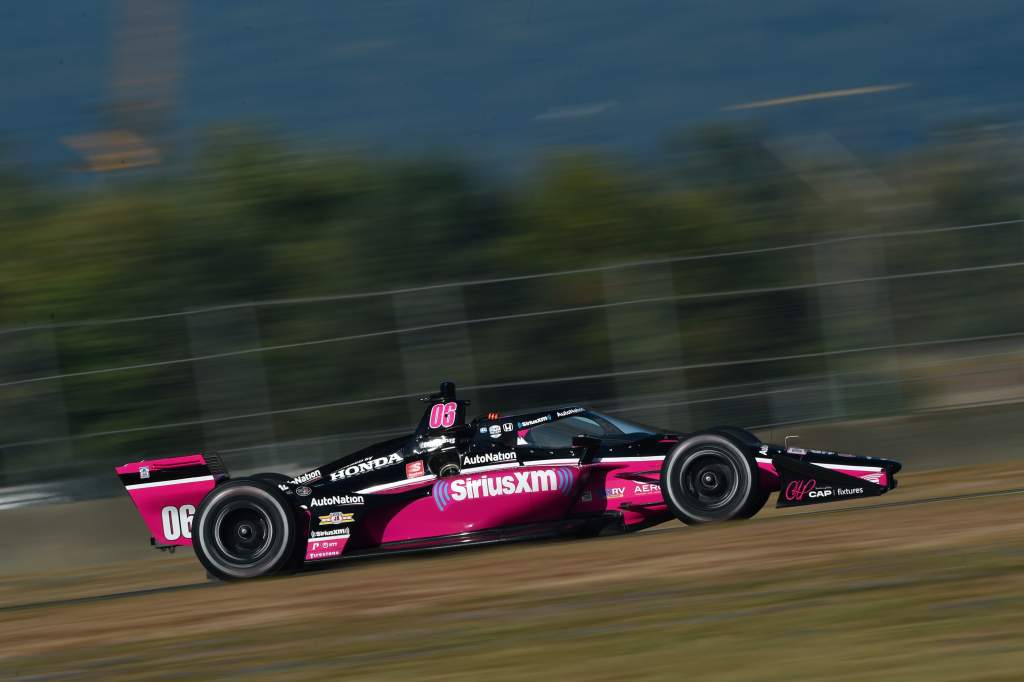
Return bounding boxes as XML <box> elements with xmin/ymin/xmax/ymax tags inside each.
<box><xmin>0</xmin><ymin>120</ymin><xmax>1024</xmax><ymax>473</ymax></box>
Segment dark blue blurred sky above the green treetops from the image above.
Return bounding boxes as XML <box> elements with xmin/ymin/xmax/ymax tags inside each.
<box><xmin>0</xmin><ymin>0</ymin><xmax>1024</xmax><ymax>169</ymax></box>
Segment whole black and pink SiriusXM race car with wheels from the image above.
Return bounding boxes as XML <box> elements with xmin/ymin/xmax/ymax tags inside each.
<box><xmin>117</xmin><ymin>382</ymin><xmax>900</xmax><ymax>580</ymax></box>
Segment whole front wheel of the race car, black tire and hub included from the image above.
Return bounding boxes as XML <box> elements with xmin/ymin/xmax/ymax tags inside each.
<box><xmin>662</xmin><ymin>433</ymin><xmax>768</xmax><ymax>525</ymax></box>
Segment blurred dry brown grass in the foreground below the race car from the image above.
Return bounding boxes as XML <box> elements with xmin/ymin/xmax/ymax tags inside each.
<box><xmin>0</xmin><ymin>458</ymin><xmax>1024</xmax><ymax>681</ymax></box>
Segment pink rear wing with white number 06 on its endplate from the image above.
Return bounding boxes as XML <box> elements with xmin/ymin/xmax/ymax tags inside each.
<box><xmin>115</xmin><ymin>454</ymin><xmax>228</xmax><ymax>547</ymax></box>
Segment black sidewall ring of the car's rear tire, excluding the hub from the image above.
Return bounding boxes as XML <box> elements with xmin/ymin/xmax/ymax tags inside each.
<box><xmin>193</xmin><ymin>479</ymin><xmax>296</xmax><ymax>581</ymax></box>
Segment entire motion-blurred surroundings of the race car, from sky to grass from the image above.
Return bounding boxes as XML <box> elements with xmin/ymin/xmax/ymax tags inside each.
<box><xmin>6</xmin><ymin>6</ymin><xmax>1024</xmax><ymax>682</ymax></box>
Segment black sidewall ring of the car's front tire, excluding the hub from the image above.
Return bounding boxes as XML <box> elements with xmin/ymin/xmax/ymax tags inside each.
<box><xmin>662</xmin><ymin>433</ymin><xmax>761</xmax><ymax>524</ymax></box>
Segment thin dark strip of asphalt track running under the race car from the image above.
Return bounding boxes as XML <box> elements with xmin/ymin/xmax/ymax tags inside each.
<box><xmin>0</xmin><ymin>487</ymin><xmax>1024</xmax><ymax>613</ymax></box>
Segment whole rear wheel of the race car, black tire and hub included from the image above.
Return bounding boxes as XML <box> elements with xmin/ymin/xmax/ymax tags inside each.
<box><xmin>193</xmin><ymin>478</ymin><xmax>298</xmax><ymax>581</ymax></box>
